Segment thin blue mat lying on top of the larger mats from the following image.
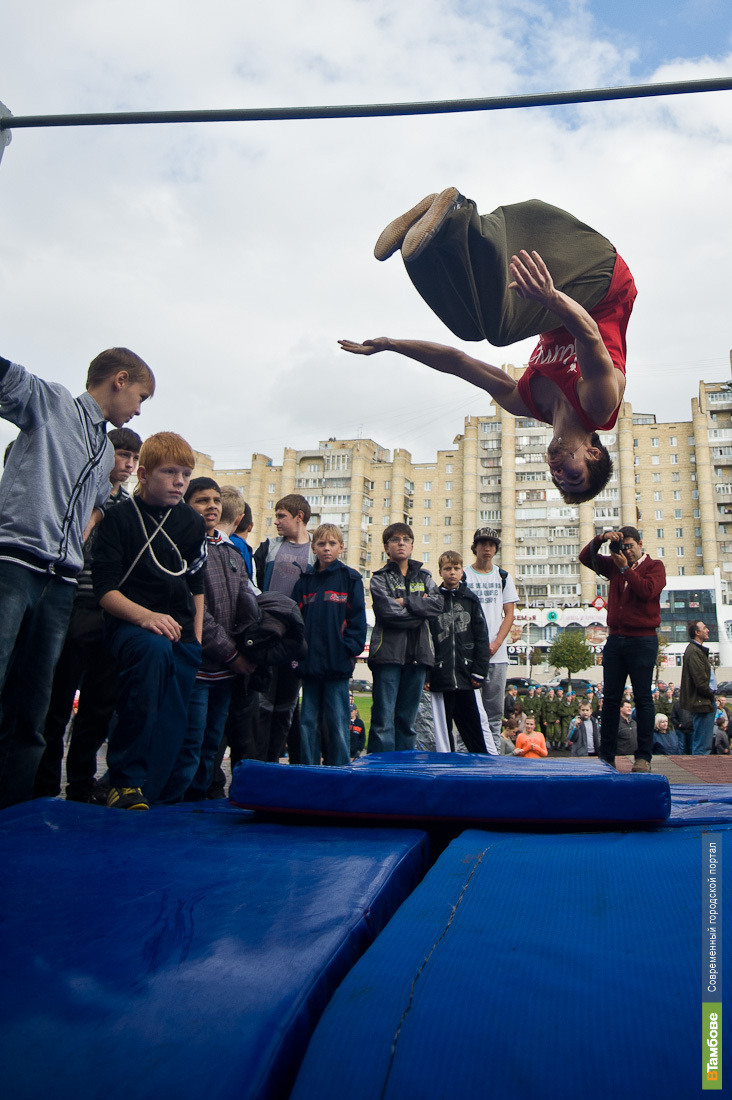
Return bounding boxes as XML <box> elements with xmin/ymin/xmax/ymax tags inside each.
<box><xmin>230</xmin><ymin>752</ymin><xmax>670</xmax><ymax>825</ymax></box>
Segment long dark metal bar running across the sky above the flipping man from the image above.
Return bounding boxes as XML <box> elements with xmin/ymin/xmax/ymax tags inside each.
<box><xmin>0</xmin><ymin>77</ymin><xmax>732</xmax><ymax>131</ymax></box>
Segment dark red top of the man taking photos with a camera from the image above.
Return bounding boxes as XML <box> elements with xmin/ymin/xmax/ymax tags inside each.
<box><xmin>579</xmin><ymin>536</ymin><xmax>666</xmax><ymax>637</ymax></box>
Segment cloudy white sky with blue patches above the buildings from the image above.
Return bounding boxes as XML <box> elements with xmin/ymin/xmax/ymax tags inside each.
<box><xmin>0</xmin><ymin>0</ymin><xmax>732</xmax><ymax>466</ymax></box>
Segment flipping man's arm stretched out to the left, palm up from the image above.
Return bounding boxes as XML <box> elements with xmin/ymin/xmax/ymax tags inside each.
<box><xmin>338</xmin><ymin>337</ymin><xmax>529</xmax><ymax>416</ymax></box>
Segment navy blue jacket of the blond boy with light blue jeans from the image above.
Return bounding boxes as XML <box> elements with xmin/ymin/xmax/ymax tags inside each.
<box><xmin>293</xmin><ymin>561</ymin><xmax>365</xmax><ymax>680</ymax></box>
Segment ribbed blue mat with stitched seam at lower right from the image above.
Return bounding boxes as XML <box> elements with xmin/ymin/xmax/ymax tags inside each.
<box><xmin>291</xmin><ymin>826</ymin><xmax>732</xmax><ymax>1100</ymax></box>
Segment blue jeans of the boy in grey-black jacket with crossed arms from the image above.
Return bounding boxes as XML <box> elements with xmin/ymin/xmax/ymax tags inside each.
<box><xmin>369</xmin><ymin>664</ymin><xmax>427</xmax><ymax>752</ymax></box>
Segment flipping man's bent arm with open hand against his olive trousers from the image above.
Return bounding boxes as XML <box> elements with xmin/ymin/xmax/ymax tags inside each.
<box><xmin>509</xmin><ymin>249</ymin><xmax>623</xmax><ymax>421</ymax></box>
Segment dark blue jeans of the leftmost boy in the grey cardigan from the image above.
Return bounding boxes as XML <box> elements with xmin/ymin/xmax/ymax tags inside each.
<box><xmin>0</xmin><ymin>561</ymin><xmax>76</xmax><ymax>809</ymax></box>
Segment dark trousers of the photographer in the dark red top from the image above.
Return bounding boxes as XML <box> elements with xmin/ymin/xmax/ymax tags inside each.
<box><xmin>600</xmin><ymin>634</ymin><xmax>658</xmax><ymax>762</ymax></box>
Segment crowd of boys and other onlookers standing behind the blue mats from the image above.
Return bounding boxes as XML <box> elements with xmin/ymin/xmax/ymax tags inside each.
<box><xmin>0</xmin><ymin>349</ymin><xmax>729</xmax><ymax>810</ymax></box>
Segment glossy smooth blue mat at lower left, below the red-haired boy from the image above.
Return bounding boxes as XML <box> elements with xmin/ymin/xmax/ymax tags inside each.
<box><xmin>0</xmin><ymin>800</ymin><xmax>427</xmax><ymax>1100</ymax></box>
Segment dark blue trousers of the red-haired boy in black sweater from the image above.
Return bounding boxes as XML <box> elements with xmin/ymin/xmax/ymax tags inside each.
<box><xmin>102</xmin><ymin>619</ymin><xmax>200</xmax><ymax>802</ymax></box>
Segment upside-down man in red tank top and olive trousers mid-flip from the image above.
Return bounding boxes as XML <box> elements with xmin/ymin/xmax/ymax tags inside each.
<box><xmin>339</xmin><ymin>187</ymin><xmax>636</xmax><ymax>504</ymax></box>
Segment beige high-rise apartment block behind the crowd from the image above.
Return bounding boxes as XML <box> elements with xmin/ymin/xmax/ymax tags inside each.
<box><xmin>196</xmin><ymin>365</ymin><xmax>732</xmax><ymax>624</ymax></box>
